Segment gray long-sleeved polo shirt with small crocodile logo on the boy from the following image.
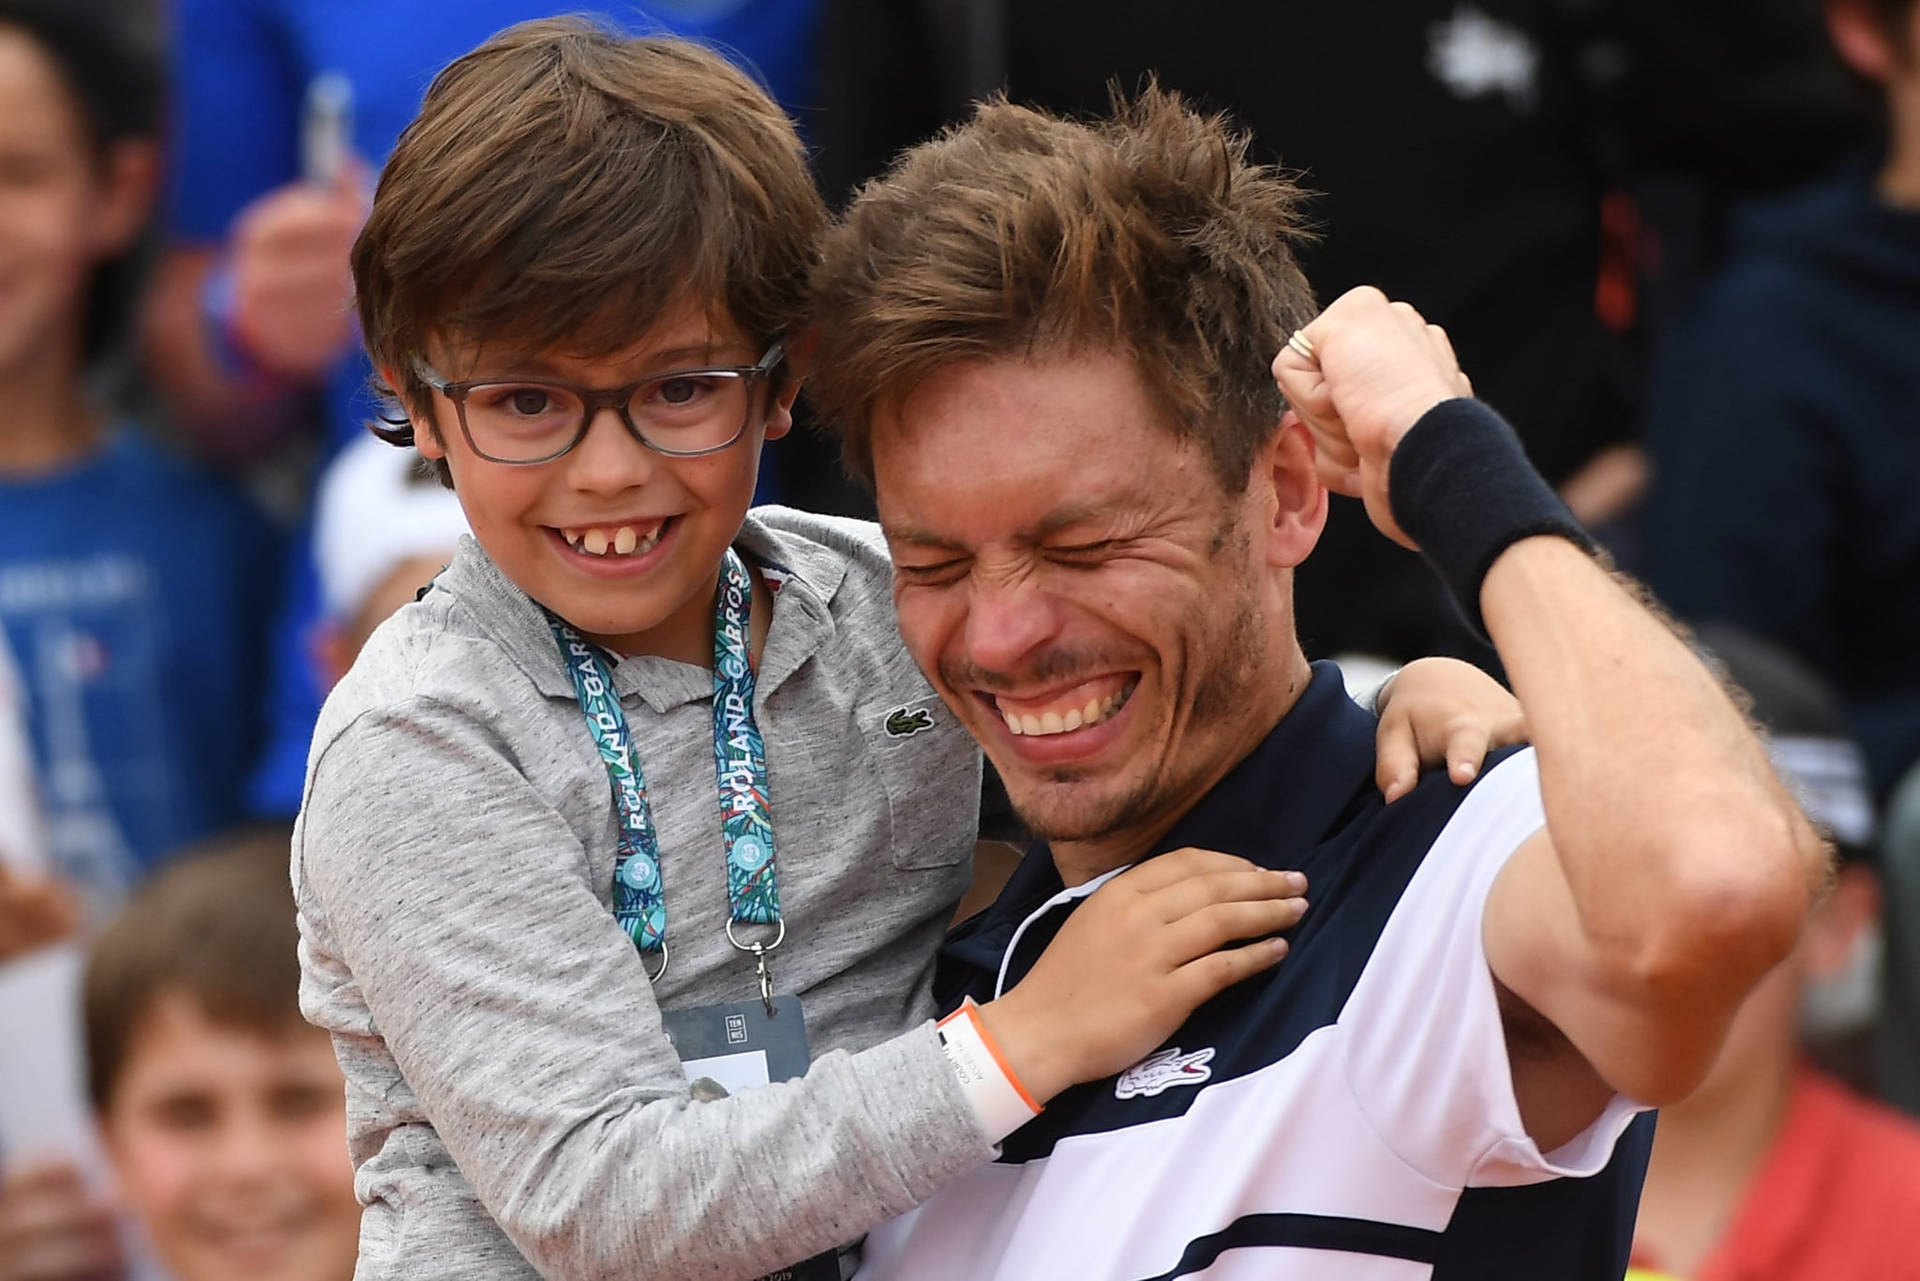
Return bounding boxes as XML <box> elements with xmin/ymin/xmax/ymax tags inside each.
<box><xmin>292</xmin><ymin>509</ymin><xmax>993</xmax><ymax>1281</ymax></box>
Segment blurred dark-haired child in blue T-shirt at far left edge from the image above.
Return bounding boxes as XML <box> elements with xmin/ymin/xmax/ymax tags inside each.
<box><xmin>0</xmin><ymin>0</ymin><xmax>275</xmax><ymax>918</ymax></box>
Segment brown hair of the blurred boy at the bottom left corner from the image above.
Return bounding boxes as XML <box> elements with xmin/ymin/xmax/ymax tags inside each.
<box><xmin>83</xmin><ymin>824</ymin><xmax>300</xmax><ymax>1112</ymax></box>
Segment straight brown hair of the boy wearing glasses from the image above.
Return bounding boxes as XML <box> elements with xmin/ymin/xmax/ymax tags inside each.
<box><xmin>353</xmin><ymin>17</ymin><xmax>826</xmax><ymax>468</ymax></box>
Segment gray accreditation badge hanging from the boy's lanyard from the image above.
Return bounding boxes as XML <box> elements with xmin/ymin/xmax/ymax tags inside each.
<box><xmin>660</xmin><ymin>997</ymin><xmax>841</xmax><ymax>1281</ymax></box>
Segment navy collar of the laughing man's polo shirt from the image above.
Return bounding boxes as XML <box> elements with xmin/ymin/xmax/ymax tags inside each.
<box><xmin>945</xmin><ymin>661</ymin><xmax>1377</xmax><ymax>972</ymax></box>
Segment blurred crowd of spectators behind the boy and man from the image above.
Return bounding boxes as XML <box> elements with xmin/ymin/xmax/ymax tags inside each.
<box><xmin>0</xmin><ymin>0</ymin><xmax>1920</xmax><ymax>1281</ymax></box>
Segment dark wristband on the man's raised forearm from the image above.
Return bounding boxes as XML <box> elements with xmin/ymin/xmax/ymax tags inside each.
<box><xmin>1386</xmin><ymin>399</ymin><xmax>1597</xmax><ymax>636</ymax></box>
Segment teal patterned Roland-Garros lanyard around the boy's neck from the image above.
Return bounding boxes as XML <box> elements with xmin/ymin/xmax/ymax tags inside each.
<box><xmin>547</xmin><ymin>547</ymin><xmax>787</xmax><ymax>1004</ymax></box>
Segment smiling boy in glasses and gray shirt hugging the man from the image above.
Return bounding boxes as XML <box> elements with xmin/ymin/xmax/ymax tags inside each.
<box><xmin>294</xmin><ymin>21</ymin><xmax>1520</xmax><ymax>1281</ymax></box>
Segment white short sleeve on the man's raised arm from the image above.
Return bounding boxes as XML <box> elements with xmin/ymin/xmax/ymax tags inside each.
<box><xmin>1340</xmin><ymin>749</ymin><xmax>1640</xmax><ymax>1187</ymax></box>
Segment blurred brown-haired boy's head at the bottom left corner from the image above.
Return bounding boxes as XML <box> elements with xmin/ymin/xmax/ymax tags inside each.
<box><xmin>86</xmin><ymin>828</ymin><xmax>359</xmax><ymax>1281</ymax></box>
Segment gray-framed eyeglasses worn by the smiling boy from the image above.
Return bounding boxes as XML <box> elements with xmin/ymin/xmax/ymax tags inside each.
<box><xmin>413</xmin><ymin>340</ymin><xmax>787</xmax><ymax>465</ymax></box>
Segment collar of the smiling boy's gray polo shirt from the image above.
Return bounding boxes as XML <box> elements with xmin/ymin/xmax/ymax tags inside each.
<box><xmin>434</xmin><ymin>513</ymin><xmax>847</xmax><ymax>714</ymax></box>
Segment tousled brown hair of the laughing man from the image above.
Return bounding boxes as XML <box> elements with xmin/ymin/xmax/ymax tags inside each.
<box><xmin>808</xmin><ymin>85</ymin><xmax>1313</xmax><ymax>494</ymax></box>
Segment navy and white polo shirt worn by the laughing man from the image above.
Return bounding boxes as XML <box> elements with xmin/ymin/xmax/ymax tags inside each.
<box><xmin>860</xmin><ymin>663</ymin><xmax>1653</xmax><ymax>1281</ymax></box>
